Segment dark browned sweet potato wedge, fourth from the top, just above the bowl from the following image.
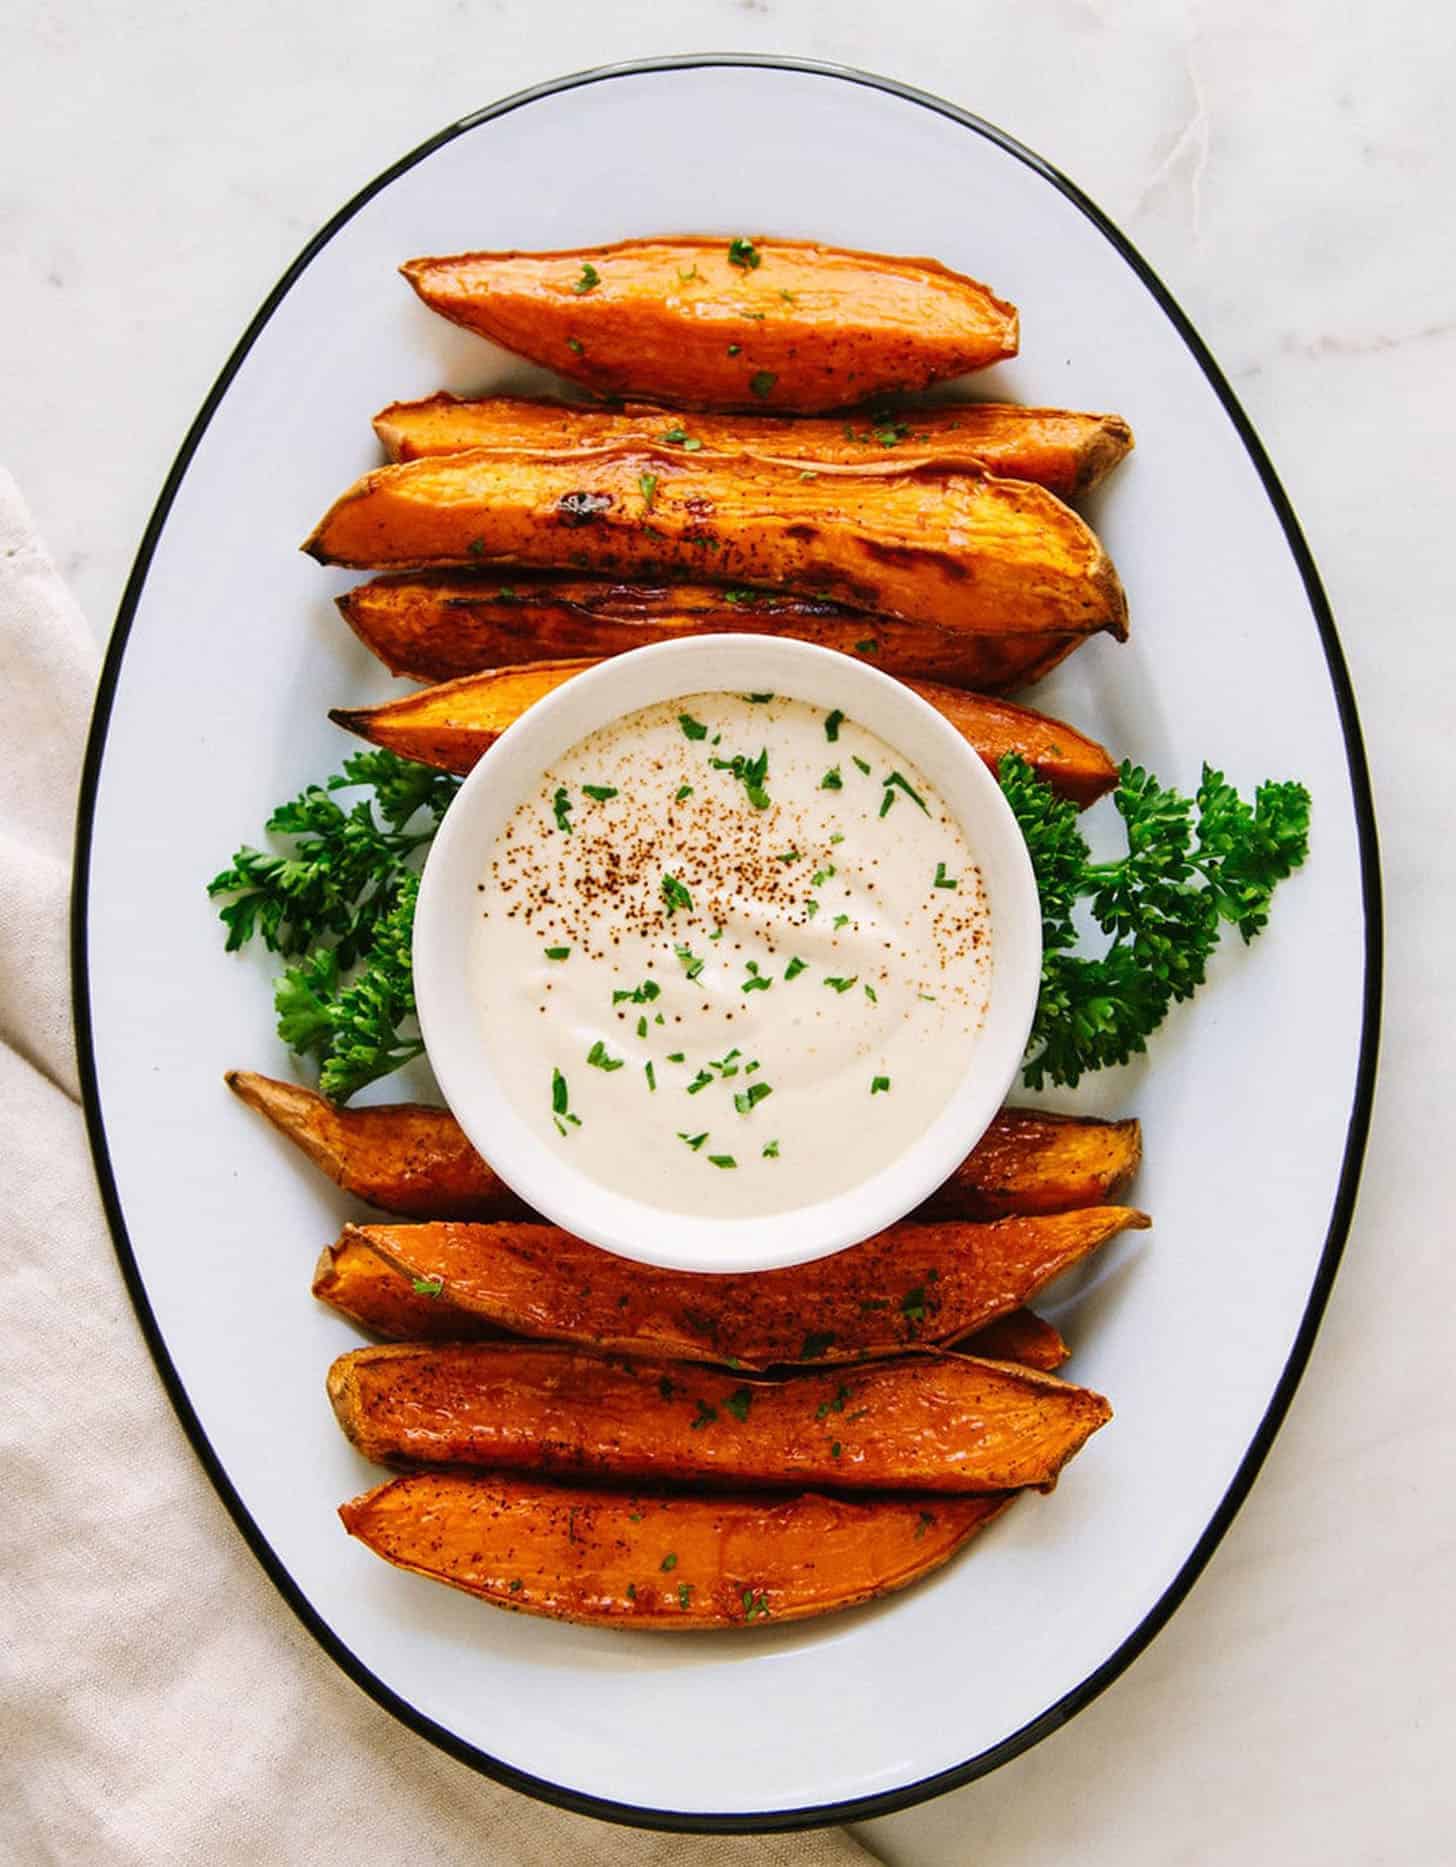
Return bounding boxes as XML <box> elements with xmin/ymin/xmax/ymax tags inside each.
<box><xmin>336</xmin><ymin>571</ymin><xmax>1086</xmax><ymax>693</ymax></box>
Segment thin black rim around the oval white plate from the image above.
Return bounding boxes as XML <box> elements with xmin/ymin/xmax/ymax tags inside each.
<box><xmin>71</xmin><ymin>52</ymin><xmax>1383</xmax><ymax>1833</ymax></box>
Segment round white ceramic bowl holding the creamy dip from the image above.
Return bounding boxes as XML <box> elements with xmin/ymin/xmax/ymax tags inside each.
<box><xmin>414</xmin><ymin>635</ymin><xmax>1042</xmax><ymax>1273</ymax></box>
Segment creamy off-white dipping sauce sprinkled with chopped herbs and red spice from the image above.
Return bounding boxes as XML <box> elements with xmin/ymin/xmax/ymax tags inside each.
<box><xmin>470</xmin><ymin>693</ymin><xmax>991</xmax><ymax>1217</ymax></box>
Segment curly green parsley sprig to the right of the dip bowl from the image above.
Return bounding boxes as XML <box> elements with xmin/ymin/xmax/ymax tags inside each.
<box><xmin>999</xmin><ymin>756</ymin><xmax>1310</xmax><ymax>1088</ymax></box>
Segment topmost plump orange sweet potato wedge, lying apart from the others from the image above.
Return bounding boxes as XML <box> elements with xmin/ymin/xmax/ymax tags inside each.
<box><xmin>399</xmin><ymin>239</ymin><xmax>1017</xmax><ymax>413</ymax></box>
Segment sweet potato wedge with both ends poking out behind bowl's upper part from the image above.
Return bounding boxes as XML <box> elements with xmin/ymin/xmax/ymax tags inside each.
<box><xmin>329</xmin><ymin>661</ymin><xmax>1118</xmax><ymax>805</ymax></box>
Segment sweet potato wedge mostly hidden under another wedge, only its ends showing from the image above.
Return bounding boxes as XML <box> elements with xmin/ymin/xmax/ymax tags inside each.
<box><xmin>314</xmin><ymin>1232</ymin><xmax>1070</xmax><ymax>1374</ymax></box>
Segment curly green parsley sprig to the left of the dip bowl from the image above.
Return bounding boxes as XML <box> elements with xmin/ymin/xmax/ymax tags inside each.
<box><xmin>207</xmin><ymin>751</ymin><xmax>459</xmax><ymax>1102</ymax></box>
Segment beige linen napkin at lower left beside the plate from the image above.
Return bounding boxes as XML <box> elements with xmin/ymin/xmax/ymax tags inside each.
<box><xmin>0</xmin><ymin>472</ymin><xmax>872</xmax><ymax>1867</ymax></box>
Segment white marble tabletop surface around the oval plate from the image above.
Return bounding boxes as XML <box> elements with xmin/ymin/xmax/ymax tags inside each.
<box><xmin>0</xmin><ymin>0</ymin><xmax>1456</xmax><ymax>1867</ymax></box>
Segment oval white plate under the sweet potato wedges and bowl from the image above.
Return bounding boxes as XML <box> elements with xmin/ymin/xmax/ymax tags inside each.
<box><xmin>75</xmin><ymin>58</ymin><xmax>1379</xmax><ymax>1828</ymax></box>
